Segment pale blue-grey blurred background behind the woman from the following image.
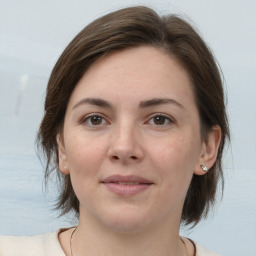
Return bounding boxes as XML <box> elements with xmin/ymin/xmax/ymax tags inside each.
<box><xmin>0</xmin><ymin>0</ymin><xmax>256</xmax><ymax>256</ymax></box>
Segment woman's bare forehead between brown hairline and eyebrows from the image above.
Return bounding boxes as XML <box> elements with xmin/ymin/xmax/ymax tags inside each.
<box><xmin>67</xmin><ymin>46</ymin><xmax>194</xmax><ymax>107</ymax></box>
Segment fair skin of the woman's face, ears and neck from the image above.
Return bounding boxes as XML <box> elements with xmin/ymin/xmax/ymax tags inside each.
<box><xmin>57</xmin><ymin>46</ymin><xmax>220</xmax><ymax>256</ymax></box>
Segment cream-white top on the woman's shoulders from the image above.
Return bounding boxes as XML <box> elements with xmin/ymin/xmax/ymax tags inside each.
<box><xmin>0</xmin><ymin>230</ymin><xmax>220</xmax><ymax>256</ymax></box>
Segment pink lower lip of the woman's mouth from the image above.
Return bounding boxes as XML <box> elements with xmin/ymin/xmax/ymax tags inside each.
<box><xmin>103</xmin><ymin>183</ymin><xmax>152</xmax><ymax>196</ymax></box>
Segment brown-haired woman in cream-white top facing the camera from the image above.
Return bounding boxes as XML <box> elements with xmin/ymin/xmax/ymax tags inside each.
<box><xmin>0</xmin><ymin>7</ymin><xmax>229</xmax><ymax>256</ymax></box>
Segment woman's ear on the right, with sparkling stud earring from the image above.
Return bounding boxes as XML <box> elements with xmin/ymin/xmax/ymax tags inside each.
<box><xmin>194</xmin><ymin>125</ymin><xmax>221</xmax><ymax>175</ymax></box>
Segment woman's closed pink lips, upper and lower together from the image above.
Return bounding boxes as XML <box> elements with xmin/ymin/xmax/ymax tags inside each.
<box><xmin>101</xmin><ymin>175</ymin><xmax>154</xmax><ymax>196</ymax></box>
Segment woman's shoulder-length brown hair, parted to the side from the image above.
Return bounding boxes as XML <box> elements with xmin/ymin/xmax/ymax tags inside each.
<box><xmin>37</xmin><ymin>6</ymin><xmax>229</xmax><ymax>225</ymax></box>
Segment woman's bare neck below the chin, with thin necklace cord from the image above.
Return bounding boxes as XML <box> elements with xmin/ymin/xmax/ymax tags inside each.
<box><xmin>72</xmin><ymin>212</ymin><xmax>186</xmax><ymax>256</ymax></box>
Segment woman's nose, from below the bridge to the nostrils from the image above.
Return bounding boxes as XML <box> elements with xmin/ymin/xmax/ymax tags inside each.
<box><xmin>108</xmin><ymin>122</ymin><xmax>144</xmax><ymax>164</ymax></box>
